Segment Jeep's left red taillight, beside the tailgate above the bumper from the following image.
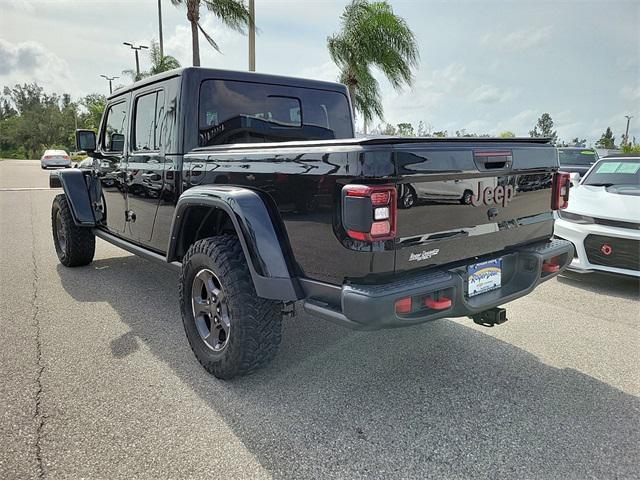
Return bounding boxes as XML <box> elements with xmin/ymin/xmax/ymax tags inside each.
<box><xmin>342</xmin><ymin>185</ymin><xmax>397</xmax><ymax>242</ymax></box>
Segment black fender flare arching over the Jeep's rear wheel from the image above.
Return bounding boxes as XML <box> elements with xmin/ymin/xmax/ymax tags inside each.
<box><xmin>167</xmin><ymin>184</ymin><xmax>303</xmax><ymax>301</ymax></box>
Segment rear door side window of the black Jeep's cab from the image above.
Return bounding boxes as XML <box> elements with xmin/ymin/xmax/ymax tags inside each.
<box><xmin>132</xmin><ymin>91</ymin><xmax>164</xmax><ymax>152</ymax></box>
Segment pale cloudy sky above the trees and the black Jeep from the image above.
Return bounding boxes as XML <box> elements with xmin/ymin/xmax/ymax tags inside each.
<box><xmin>0</xmin><ymin>0</ymin><xmax>640</xmax><ymax>142</ymax></box>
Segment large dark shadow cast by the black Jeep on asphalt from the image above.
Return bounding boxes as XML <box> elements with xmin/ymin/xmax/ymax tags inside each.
<box><xmin>58</xmin><ymin>256</ymin><xmax>640</xmax><ymax>479</ymax></box>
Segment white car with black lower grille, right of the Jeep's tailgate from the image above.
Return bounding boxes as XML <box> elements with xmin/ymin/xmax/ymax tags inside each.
<box><xmin>554</xmin><ymin>155</ymin><xmax>640</xmax><ymax>277</ymax></box>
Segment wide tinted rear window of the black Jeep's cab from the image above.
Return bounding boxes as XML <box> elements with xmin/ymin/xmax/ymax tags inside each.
<box><xmin>198</xmin><ymin>80</ymin><xmax>353</xmax><ymax>147</ymax></box>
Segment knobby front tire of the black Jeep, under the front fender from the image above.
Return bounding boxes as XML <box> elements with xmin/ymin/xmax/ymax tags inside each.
<box><xmin>51</xmin><ymin>193</ymin><xmax>96</xmax><ymax>267</ymax></box>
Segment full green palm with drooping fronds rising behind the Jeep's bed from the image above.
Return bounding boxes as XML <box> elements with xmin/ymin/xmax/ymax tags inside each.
<box><xmin>327</xmin><ymin>0</ymin><xmax>420</xmax><ymax>128</ymax></box>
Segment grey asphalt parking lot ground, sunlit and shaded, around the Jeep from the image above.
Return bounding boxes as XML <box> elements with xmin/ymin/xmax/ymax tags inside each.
<box><xmin>0</xmin><ymin>161</ymin><xmax>640</xmax><ymax>479</ymax></box>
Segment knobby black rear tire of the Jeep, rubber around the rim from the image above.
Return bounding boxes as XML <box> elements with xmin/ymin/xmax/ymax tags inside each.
<box><xmin>178</xmin><ymin>235</ymin><xmax>282</xmax><ymax>380</ymax></box>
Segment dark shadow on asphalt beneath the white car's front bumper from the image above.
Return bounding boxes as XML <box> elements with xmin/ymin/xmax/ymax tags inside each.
<box><xmin>556</xmin><ymin>270</ymin><xmax>640</xmax><ymax>300</ymax></box>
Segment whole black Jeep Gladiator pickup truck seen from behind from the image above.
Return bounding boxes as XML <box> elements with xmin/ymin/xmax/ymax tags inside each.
<box><xmin>51</xmin><ymin>68</ymin><xmax>573</xmax><ymax>379</ymax></box>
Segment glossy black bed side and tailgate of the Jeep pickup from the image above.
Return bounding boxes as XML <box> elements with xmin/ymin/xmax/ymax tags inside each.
<box><xmin>185</xmin><ymin>137</ymin><xmax>558</xmax><ymax>284</ymax></box>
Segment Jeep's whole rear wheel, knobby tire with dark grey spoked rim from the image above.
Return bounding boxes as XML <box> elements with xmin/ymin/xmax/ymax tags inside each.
<box><xmin>179</xmin><ymin>235</ymin><xmax>282</xmax><ymax>380</ymax></box>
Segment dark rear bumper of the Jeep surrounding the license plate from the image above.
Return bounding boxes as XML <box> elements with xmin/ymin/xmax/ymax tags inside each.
<box><xmin>304</xmin><ymin>239</ymin><xmax>573</xmax><ymax>330</ymax></box>
